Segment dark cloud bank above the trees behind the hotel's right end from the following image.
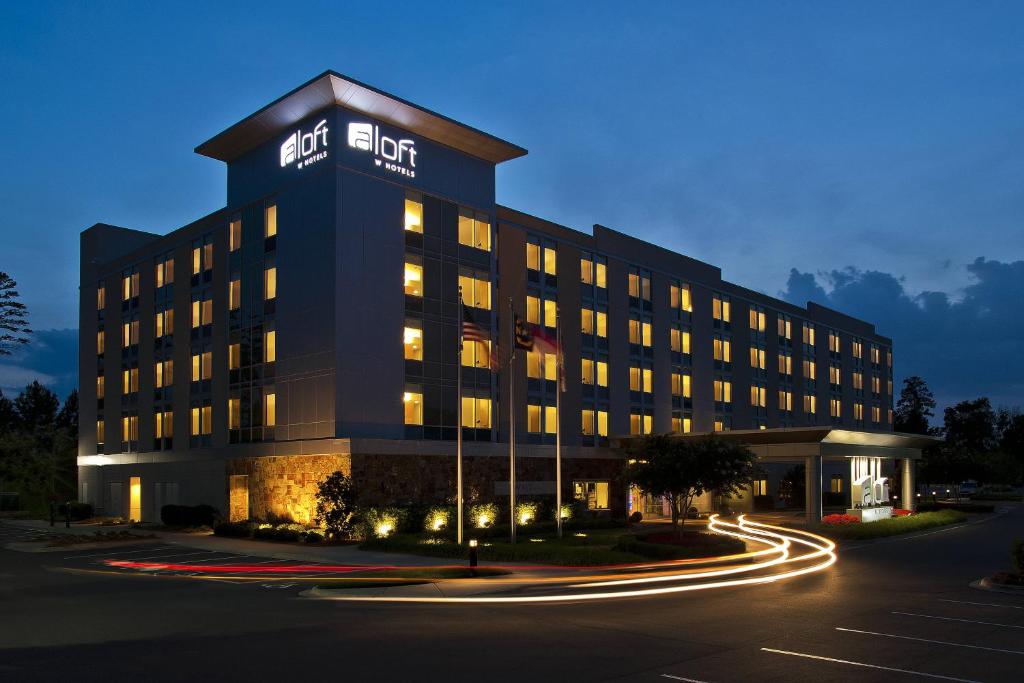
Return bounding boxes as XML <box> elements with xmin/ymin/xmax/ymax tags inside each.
<box><xmin>780</xmin><ymin>257</ymin><xmax>1024</xmax><ymax>405</ymax></box>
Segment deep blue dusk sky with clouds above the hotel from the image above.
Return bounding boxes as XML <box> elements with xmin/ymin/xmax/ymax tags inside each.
<box><xmin>0</xmin><ymin>2</ymin><xmax>1024</xmax><ymax>417</ymax></box>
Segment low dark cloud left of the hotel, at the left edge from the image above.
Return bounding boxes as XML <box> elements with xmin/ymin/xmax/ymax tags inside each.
<box><xmin>0</xmin><ymin>330</ymin><xmax>78</xmax><ymax>398</ymax></box>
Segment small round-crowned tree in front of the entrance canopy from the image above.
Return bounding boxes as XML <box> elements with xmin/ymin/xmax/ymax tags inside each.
<box><xmin>626</xmin><ymin>435</ymin><xmax>756</xmax><ymax>533</ymax></box>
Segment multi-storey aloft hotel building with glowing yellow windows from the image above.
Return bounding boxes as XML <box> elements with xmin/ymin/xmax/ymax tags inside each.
<box><xmin>79</xmin><ymin>72</ymin><xmax>905</xmax><ymax>521</ymax></box>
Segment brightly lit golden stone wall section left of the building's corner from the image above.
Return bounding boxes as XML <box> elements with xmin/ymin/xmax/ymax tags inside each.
<box><xmin>226</xmin><ymin>455</ymin><xmax>351</xmax><ymax>524</ymax></box>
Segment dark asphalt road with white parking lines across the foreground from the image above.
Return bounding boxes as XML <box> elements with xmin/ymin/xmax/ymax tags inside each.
<box><xmin>0</xmin><ymin>507</ymin><xmax>1024</xmax><ymax>683</ymax></box>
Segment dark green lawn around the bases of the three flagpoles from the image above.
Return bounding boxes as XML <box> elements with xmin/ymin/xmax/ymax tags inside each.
<box><xmin>359</xmin><ymin>528</ymin><xmax>745</xmax><ymax>566</ymax></box>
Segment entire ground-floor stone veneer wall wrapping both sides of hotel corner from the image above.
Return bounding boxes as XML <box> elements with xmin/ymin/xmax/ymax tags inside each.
<box><xmin>226</xmin><ymin>454</ymin><xmax>627</xmax><ymax>523</ymax></box>
